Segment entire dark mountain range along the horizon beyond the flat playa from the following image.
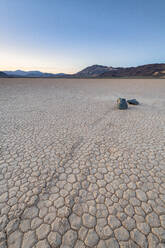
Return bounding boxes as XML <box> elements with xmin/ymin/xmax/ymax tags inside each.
<box><xmin>0</xmin><ymin>63</ymin><xmax>165</xmax><ymax>78</ymax></box>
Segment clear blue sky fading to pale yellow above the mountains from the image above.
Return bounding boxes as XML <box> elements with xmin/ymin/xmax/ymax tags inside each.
<box><xmin>0</xmin><ymin>0</ymin><xmax>165</xmax><ymax>73</ymax></box>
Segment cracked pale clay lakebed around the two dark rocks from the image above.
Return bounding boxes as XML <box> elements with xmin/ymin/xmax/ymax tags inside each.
<box><xmin>0</xmin><ymin>79</ymin><xmax>165</xmax><ymax>248</ymax></box>
